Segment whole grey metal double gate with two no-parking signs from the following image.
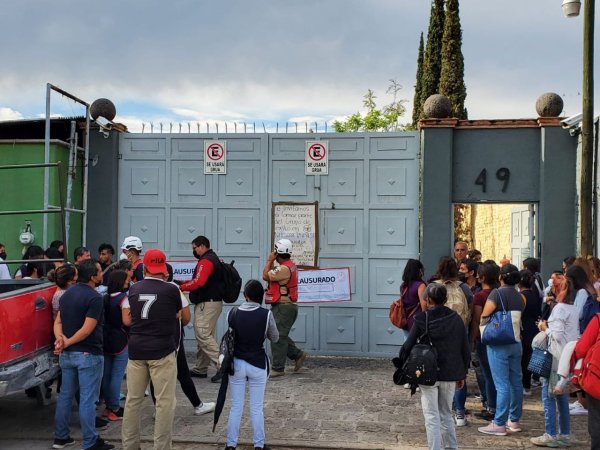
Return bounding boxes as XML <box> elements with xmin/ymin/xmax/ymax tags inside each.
<box><xmin>119</xmin><ymin>133</ymin><xmax>419</xmax><ymax>356</ymax></box>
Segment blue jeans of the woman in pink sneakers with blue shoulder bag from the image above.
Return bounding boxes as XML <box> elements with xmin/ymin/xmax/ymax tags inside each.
<box><xmin>487</xmin><ymin>342</ymin><xmax>523</xmax><ymax>426</ymax></box>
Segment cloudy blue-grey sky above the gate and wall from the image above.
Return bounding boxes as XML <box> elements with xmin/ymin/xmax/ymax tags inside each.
<box><xmin>0</xmin><ymin>0</ymin><xmax>600</xmax><ymax>132</ymax></box>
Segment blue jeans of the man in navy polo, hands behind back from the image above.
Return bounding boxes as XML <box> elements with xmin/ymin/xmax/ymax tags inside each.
<box><xmin>54</xmin><ymin>351</ymin><xmax>104</xmax><ymax>449</ymax></box>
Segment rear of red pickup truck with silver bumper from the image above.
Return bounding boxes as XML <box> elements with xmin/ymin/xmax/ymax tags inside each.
<box><xmin>0</xmin><ymin>280</ymin><xmax>60</xmax><ymax>401</ymax></box>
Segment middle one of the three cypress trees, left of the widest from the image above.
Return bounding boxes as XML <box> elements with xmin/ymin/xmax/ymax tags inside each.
<box><xmin>420</xmin><ymin>0</ymin><xmax>445</xmax><ymax>117</ymax></box>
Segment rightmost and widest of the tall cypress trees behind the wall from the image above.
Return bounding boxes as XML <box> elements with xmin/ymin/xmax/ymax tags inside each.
<box><xmin>439</xmin><ymin>0</ymin><xmax>467</xmax><ymax>119</ymax></box>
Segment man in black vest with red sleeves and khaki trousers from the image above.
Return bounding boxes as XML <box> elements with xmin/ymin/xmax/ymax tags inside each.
<box><xmin>181</xmin><ymin>236</ymin><xmax>223</xmax><ymax>383</ymax></box>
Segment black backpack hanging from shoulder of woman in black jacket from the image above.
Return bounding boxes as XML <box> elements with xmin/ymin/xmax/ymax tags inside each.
<box><xmin>394</xmin><ymin>312</ymin><xmax>439</xmax><ymax>386</ymax></box>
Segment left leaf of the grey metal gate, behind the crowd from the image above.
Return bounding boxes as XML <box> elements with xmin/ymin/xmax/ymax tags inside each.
<box><xmin>119</xmin><ymin>134</ymin><xmax>270</xmax><ymax>350</ymax></box>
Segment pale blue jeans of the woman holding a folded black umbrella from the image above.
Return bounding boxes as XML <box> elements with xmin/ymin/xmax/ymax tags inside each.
<box><xmin>227</xmin><ymin>358</ymin><xmax>267</xmax><ymax>448</ymax></box>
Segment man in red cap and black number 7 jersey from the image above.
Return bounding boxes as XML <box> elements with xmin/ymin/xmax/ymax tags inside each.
<box><xmin>122</xmin><ymin>249</ymin><xmax>182</xmax><ymax>450</ymax></box>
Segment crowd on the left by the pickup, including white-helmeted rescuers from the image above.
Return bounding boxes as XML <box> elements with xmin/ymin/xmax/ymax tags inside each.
<box><xmin>7</xmin><ymin>236</ymin><xmax>307</xmax><ymax>450</ymax></box>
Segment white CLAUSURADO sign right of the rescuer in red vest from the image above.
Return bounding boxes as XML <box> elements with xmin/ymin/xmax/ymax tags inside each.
<box><xmin>298</xmin><ymin>267</ymin><xmax>352</xmax><ymax>303</ymax></box>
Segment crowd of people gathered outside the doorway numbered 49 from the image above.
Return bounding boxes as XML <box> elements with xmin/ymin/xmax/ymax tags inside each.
<box><xmin>395</xmin><ymin>241</ymin><xmax>600</xmax><ymax>449</ymax></box>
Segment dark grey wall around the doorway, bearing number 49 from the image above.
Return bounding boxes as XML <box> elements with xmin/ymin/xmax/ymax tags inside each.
<box><xmin>420</xmin><ymin>118</ymin><xmax>577</xmax><ymax>282</ymax></box>
